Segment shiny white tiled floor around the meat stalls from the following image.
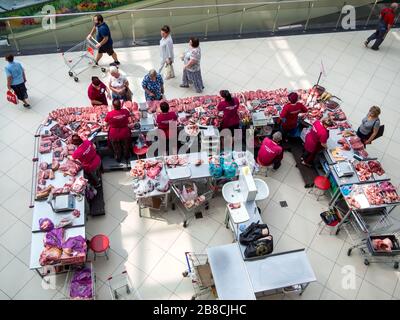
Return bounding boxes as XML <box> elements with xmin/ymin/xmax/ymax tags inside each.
<box><xmin>0</xmin><ymin>31</ymin><xmax>400</xmax><ymax>299</ymax></box>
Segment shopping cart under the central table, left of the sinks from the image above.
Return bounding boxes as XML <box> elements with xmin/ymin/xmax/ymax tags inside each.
<box><xmin>171</xmin><ymin>179</ymin><xmax>214</xmax><ymax>228</ymax></box>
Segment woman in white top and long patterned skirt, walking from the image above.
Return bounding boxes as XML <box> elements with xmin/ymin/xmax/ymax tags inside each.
<box><xmin>180</xmin><ymin>38</ymin><xmax>204</xmax><ymax>93</ymax></box>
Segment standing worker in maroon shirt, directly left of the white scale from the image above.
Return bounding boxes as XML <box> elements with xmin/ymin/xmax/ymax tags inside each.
<box><xmin>104</xmin><ymin>99</ymin><xmax>131</xmax><ymax>163</ymax></box>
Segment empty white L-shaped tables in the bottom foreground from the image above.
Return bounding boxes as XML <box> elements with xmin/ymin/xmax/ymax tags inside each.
<box><xmin>207</xmin><ymin>243</ymin><xmax>317</xmax><ymax>300</ymax></box>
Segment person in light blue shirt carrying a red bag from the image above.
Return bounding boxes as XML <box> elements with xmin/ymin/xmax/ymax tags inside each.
<box><xmin>4</xmin><ymin>54</ymin><xmax>31</xmax><ymax>108</ymax></box>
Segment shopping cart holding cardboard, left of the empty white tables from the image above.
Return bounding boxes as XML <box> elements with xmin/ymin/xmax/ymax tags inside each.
<box><xmin>182</xmin><ymin>252</ymin><xmax>217</xmax><ymax>300</ymax></box>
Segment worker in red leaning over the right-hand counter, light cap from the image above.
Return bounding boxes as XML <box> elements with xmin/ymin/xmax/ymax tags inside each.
<box><xmin>301</xmin><ymin>118</ymin><xmax>333</xmax><ymax>167</ymax></box>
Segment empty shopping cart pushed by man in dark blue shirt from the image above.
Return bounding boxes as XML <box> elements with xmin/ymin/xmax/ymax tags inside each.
<box><xmin>62</xmin><ymin>37</ymin><xmax>106</xmax><ymax>82</ymax></box>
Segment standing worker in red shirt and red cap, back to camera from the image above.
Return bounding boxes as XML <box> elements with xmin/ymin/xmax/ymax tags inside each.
<box><xmin>280</xmin><ymin>92</ymin><xmax>307</xmax><ymax>141</ymax></box>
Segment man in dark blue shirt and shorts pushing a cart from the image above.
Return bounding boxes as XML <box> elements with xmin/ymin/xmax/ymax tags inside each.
<box><xmin>87</xmin><ymin>14</ymin><xmax>120</xmax><ymax>66</ymax></box>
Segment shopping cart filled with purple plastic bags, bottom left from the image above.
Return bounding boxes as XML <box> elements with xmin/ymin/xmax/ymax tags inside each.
<box><xmin>64</xmin><ymin>262</ymin><xmax>96</xmax><ymax>300</ymax></box>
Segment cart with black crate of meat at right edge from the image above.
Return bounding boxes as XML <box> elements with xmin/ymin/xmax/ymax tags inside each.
<box><xmin>347</xmin><ymin>233</ymin><xmax>400</xmax><ymax>269</ymax></box>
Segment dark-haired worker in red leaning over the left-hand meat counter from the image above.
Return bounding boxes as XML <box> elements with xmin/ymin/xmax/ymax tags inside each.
<box><xmin>71</xmin><ymin>134</ymin><xmax>101</xmax><ymax>188</ymax></box>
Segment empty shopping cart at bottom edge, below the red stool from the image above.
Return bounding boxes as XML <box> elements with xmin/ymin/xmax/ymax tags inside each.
<box><xmin>107</xmin><ymin>271</ymin><xmax>142</xmax><ymax>300</ymax></box>
